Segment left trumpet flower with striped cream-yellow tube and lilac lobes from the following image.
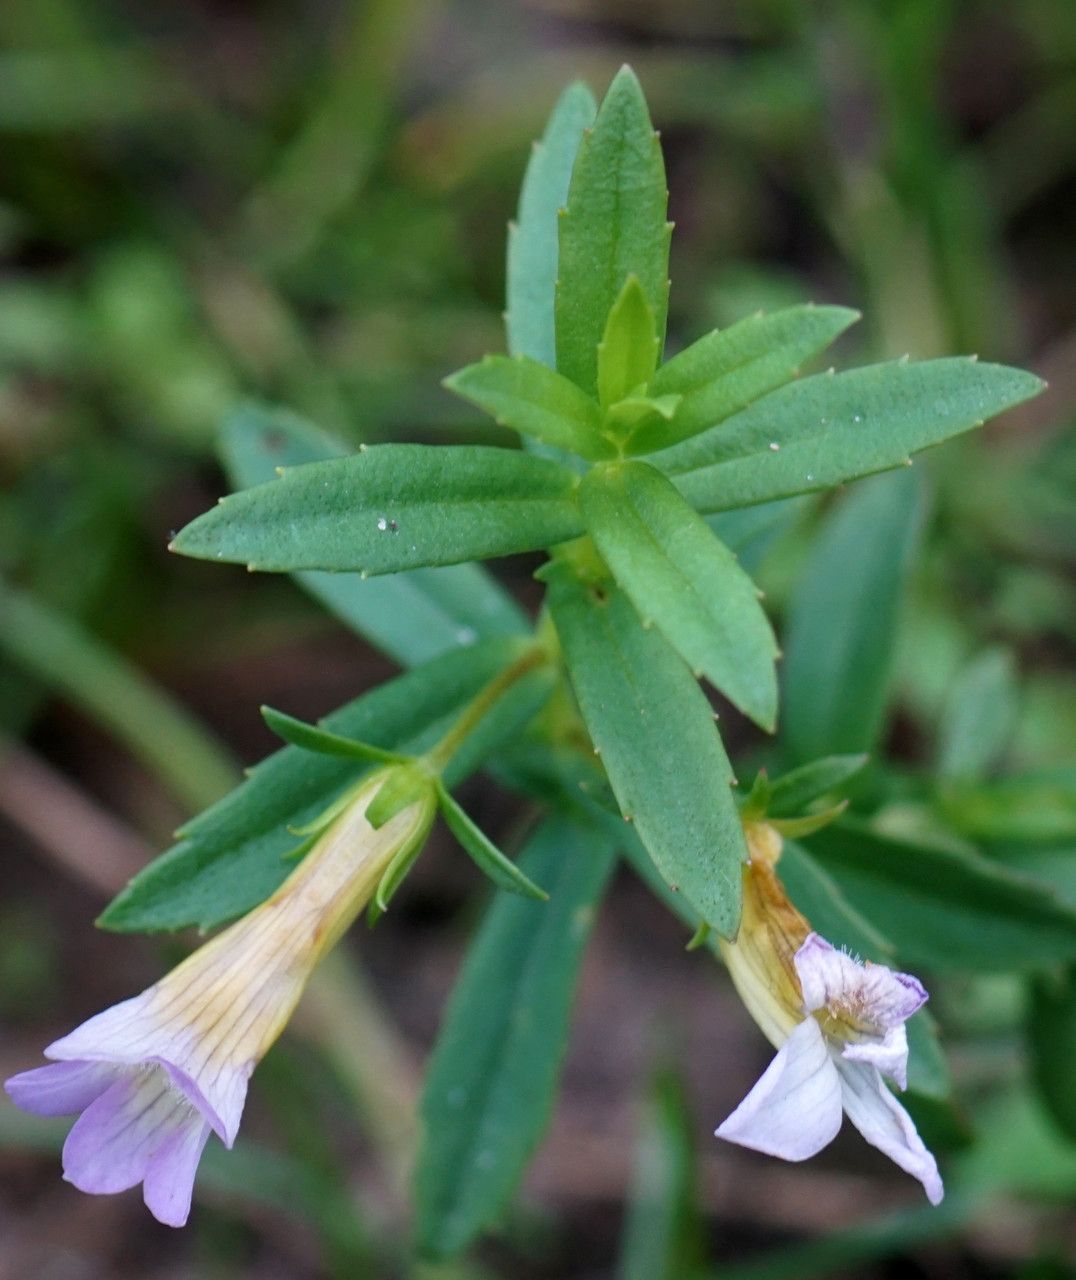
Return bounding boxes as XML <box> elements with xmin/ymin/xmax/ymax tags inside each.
<box><xmin>5</xmin><ymin>771</ymin><xmax>434</xmax><ymax>1226</ymax></box>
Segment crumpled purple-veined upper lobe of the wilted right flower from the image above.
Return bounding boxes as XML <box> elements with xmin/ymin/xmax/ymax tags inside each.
<box><xmin>795</xmin><ymin>933</ymin><xmax>926</xmax><ymax>1030</ymax></box>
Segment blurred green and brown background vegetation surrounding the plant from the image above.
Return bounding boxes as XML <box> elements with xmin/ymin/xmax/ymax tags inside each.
<box><xmin>0</xmin><ymin>0</ymin><xmax>1076</xmax><ymax>1280</ymax></box>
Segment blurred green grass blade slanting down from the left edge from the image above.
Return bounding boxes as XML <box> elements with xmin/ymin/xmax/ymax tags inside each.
<box><xmin>0</xmin><ymin>581</ymin><xmax>238</xmax><ymax>810</ymax></box>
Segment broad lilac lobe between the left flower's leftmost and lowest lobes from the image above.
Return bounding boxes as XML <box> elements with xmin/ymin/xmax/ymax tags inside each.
<box><xmin>63</xmin><ymin>1070</ymin><xmax>197</xmax><ymax>1194</ymax></box>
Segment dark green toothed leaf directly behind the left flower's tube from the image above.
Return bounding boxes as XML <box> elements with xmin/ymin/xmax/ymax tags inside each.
<box><xmin>100</xmin><ymin>639</ymin><xmax>523</xmax><ymax>932</ymax></box>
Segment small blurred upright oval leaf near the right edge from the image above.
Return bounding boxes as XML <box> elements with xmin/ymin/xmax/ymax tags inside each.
<box><xmin>938</xmin><ymin>649</ymin><xmax>1018</xmax><ymax>780</ymax></box>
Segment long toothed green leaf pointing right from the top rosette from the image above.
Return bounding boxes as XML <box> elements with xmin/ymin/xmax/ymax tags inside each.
<box><xmin>656</xmin><ymin>358</ymin><xmax>1044</xmax><ymax>512</ymax></box>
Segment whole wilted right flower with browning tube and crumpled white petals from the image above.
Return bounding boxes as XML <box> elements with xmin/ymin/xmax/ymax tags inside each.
<box><xmin>716</xmin><ymin>823</ymin><xmax>944</xmax><ymax>1204</ymax></box>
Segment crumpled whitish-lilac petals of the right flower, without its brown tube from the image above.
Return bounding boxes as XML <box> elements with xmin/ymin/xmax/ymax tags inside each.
<box><xmin>716</xmin><ymin>933</ymin><xmax>944</xmax><ymax>1204</ymax></box>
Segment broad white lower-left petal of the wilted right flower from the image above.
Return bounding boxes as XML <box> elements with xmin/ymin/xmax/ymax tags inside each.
<box><xmin>715</xmin><ymin>1018</ymin><xmax>841</xmax><ymax>1160</ymax></box>
